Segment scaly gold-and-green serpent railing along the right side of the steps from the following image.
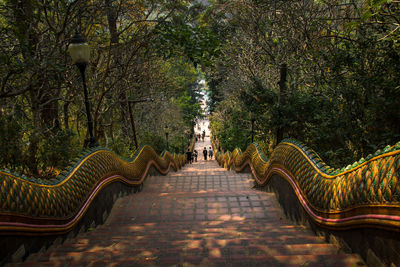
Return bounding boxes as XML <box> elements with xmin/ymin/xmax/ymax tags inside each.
<box><xmin>214</xmin><ymin>139</ymin><xmax>400</xmax><ymax>231</ymax></box>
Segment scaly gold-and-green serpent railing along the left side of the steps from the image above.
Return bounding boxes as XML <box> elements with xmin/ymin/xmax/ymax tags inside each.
<box><xmin>0</xmin><ymin>145</ymin><xmax>186</xmax><ymax>236</ymax></box>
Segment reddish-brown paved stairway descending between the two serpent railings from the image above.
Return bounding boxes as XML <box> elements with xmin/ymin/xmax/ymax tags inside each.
<box><xmin>12</xmin><ymin>138</ymin><xmax>363</xmax><ymax>266</ymax></box>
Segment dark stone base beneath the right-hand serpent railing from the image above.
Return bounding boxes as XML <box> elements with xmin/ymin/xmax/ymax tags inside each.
<box><xmin>260</xmin><ymin>175</ymin><xmax>400</xmax><ymax>266</ymax></box>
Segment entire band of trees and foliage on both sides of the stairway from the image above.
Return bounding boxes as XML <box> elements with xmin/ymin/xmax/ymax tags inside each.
<box><xmin>4</xmin><ymin>0</ymin><xmax>400</xmax><ymax>177</ymax></box>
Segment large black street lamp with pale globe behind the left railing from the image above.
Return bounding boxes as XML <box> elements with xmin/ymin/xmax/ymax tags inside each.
<box><xmin>68</xmin><ymin>33</ymin><xmax>99</xmax><ymax>148</ymax></box>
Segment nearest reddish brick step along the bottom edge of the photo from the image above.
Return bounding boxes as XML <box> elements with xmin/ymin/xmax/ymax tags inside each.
<box><xmin>9</xmin><ymin>253</ymin><xmax>365</xmax><ymax>267</ymax></box>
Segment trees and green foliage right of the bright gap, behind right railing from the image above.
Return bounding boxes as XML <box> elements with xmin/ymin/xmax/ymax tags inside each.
<box><xmin>205</xmin><ymin>0</ymin><xmax>400</xmax><ymax>167</ymax></box>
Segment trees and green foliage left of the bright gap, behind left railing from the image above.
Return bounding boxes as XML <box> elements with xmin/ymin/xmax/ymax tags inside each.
<box><xmin>0</xmin><ymin>0</ymin><xmax>206</xmax><ymax>178</ymax></box>
